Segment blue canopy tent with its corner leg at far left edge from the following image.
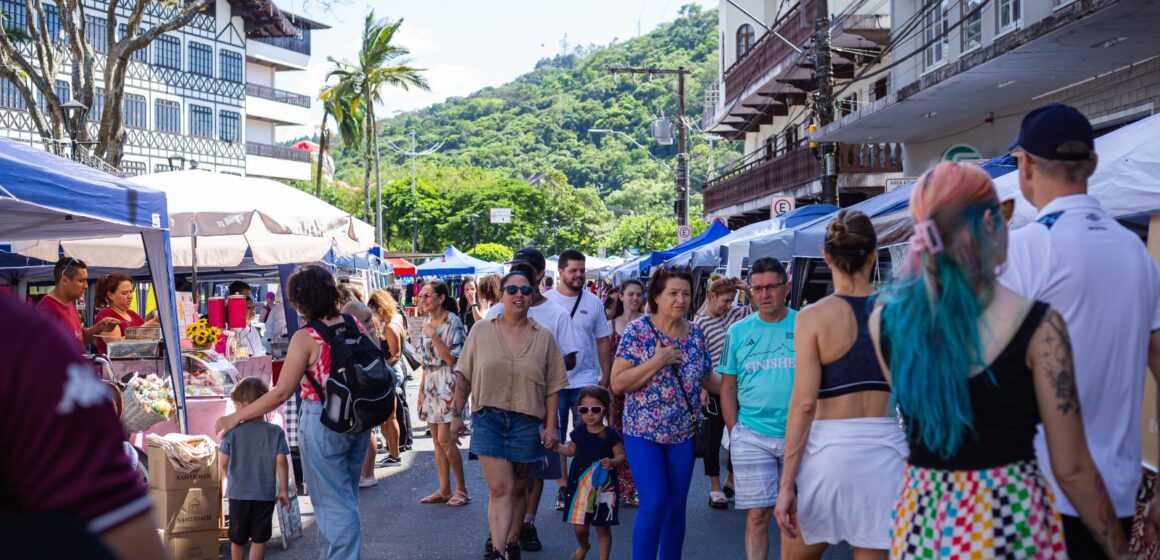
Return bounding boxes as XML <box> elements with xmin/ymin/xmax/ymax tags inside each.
<box><xmin>0</xmin><ymin>138</ymin><xmax>189</xmax><ymax>430</ymax></box>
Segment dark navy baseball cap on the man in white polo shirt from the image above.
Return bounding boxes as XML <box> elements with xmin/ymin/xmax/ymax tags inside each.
<box><xmin>1008</xmin><ymin>103</ymin><xmax>1095</xmax><ymax>161</ymax></box>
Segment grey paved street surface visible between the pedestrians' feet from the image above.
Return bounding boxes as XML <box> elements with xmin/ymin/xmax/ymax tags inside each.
<box><xmin>268</xmin><ymin>386</ymin><xmax>851</xmax><ymax>560</ymax></box>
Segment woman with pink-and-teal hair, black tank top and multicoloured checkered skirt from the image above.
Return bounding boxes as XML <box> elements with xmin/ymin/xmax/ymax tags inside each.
<box><xmin>870</xmin><ymin>162</ymin><xmax>1129</xmax><ymax>559</ymax></box>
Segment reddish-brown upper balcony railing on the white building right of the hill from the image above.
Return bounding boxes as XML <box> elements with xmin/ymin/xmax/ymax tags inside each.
<box><xmin>722</xmin><ymin>0</ymin><xmax>818</xmax><ymax>106</ymax></box>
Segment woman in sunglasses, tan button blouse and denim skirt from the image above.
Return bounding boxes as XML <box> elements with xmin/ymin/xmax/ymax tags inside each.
<box><xmin>451</xmin><ymin>268</ymin><xmax>568</xmax><ymax>559</ymax></box>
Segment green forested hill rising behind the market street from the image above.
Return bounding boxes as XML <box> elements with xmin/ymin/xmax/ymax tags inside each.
<box><xmin>313</xmin><ymin>5</ymin><xmax>737</xmax><ymax>252</ymax></box>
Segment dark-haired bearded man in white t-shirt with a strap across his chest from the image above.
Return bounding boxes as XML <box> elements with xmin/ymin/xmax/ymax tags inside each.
<box><xmin>544</xmin><ymin>249</ymin><xmax>614</xmax><ymax>509</ymax></box>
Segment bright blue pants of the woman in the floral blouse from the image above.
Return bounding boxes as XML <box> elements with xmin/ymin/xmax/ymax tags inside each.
<box><xmin>624</xmin><ymin>436</ymin><xmax>696</xmax><ymax>560</ymax></box>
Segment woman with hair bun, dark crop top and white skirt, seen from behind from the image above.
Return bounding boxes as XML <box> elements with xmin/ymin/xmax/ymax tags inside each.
<box><xmin>775</xmin><ymin>210</ymin><xmax>906</xmax><ymax>559</ymax></box>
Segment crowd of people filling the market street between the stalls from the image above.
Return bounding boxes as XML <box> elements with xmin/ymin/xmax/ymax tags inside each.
<box><xmin>0</xmin><ymin>100</ymin><xmax>1160</xmax><ymax>560</ymax></box>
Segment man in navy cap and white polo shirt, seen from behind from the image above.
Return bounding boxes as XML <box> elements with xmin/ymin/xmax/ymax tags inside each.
<box><xmin>1000</xmin><ymin>103</ymin><xmax>1160</xmax><ymax>559</ymax></box>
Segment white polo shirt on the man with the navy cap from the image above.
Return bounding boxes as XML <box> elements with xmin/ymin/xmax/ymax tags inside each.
<box><xmin>1000</xmin><ymin>195</ymin><xmax>1160</xmax><ymax>517</ymax></box>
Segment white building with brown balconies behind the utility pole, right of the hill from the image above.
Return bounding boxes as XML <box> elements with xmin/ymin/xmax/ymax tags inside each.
<box><xmin>702</xmin><ymin>0</ymin><xmax>902</xmax><ymax>226</ymax></box>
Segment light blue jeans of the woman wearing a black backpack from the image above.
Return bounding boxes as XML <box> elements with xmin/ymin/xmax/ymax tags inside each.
<box><xmin>298</xmin><ymin>399</ymin><xmax>370</xmax><ymax>560</ymax></box>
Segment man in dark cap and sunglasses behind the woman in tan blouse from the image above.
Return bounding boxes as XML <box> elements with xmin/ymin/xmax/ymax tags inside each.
<box><xmin>486</xmin><ymin>247</ymin><xmax>584</xmax><ymax>552</ymax></box>
